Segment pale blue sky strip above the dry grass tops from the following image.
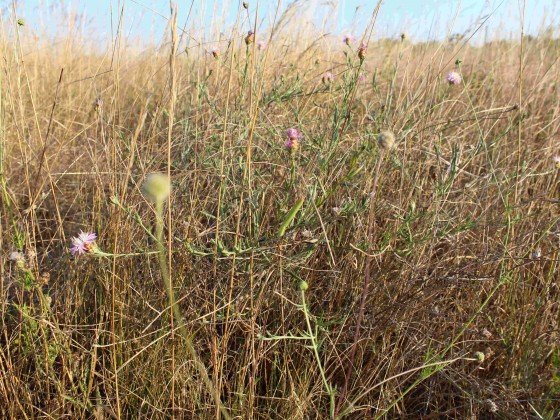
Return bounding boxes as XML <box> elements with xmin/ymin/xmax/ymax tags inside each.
<box><xmin>8</xmin><ymin>0</ymin><xmax>560</xmax><ymax>43</ymax></box>
